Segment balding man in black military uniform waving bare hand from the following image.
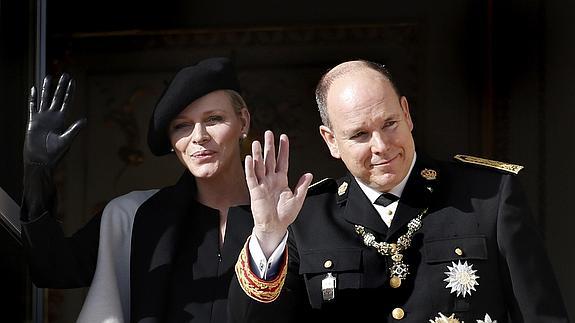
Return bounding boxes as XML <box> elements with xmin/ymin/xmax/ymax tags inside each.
<box><xmin>230</xmin><ymin>61</ymin><xmax>568</xmax><ymax>323</ymax></box>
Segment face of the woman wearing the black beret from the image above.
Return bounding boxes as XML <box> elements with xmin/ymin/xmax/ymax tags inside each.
<box><xmin>168</xmin><ymin>90</ymin><xmax>250</xmax><ymax>179</ymax></box>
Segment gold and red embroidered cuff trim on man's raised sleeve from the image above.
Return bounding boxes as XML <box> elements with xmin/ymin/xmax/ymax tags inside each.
<box><xmin>235</xmin><ymin>238</ymin><xmax>288</xmax><ymax>303</ymax></box>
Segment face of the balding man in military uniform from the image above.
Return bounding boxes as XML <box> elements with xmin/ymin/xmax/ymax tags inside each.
<box><xmin>320</xmin><ymin>68</ymin><xmax>415</xmax><ymax>192</ymax></box>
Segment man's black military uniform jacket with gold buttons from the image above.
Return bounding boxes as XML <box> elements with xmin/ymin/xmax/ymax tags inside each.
<box><xmin>229</xmin><ymin>155</ymin><xmax>568</xmax><ymax>323</ymax></box>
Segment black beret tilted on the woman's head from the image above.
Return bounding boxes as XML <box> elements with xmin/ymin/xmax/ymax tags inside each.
<box><xmin>148</xmin><ymin>57</ymin><xmax>240</xmax><ymax>156</ymax></box>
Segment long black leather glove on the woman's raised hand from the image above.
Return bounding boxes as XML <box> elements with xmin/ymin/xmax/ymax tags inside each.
<box><xmin>20</xmin><ymin>74</ymin><xmax>86</xmax><ymax>222</ymax></box>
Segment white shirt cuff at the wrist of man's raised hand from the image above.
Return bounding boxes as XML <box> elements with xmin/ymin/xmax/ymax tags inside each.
<box><xmin>248</xmin><ymin>232</ymin><xmax>288</xmax><ymax>280</ymax></box>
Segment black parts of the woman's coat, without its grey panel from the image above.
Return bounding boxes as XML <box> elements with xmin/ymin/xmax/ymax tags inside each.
<box><xmin>23</xmin><ymin>172</ymin><xmax>253</xmax><ymax>323</ymax></box>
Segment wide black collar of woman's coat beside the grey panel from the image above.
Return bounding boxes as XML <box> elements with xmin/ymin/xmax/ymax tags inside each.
<box><xmin>130</xmin><ymin>172</ymin><xmax>196</xmax><ymax>323</ymax></box>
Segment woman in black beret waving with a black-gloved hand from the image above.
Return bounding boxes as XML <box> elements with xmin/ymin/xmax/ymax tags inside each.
<box><xmin>21</xmin><ymin>58</ymin><xmax>253</xmax><ymax>323</ymax></box>
